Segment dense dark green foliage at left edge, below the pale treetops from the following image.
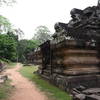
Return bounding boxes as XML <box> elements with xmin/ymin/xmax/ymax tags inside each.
<box><xmin>0</xmin><ymin>34</ymin><xmax>17</xmax><ymax>61</ymax></box>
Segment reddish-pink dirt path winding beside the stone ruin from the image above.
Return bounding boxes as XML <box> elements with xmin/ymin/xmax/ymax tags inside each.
<box><xmin>6</xmin><ymin>64</ymin><xmax>48</xmax><ymax>100</ymax></box>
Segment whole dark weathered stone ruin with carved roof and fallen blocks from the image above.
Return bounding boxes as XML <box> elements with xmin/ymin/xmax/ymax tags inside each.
<box><xmin>29</xmin><ymin>0</ymin><xmax>100</xmax><ymax>100</ymax></box>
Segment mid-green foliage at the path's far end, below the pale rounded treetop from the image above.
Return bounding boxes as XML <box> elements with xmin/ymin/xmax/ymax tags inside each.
<box><xmin>17</xmin><ymin>39</ymin><xmax>38</xmax><ymax>62</ymax></box>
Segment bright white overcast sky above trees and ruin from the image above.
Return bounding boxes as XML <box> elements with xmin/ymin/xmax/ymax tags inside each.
<box><xmin>0</xmin><ymin>0</ymin><xmax>98</xmax><ymax>39</ymax></box>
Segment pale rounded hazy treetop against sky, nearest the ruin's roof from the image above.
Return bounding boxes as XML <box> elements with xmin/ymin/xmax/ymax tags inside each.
<box><xmin>33</xmin><ymin>26</ymin><xmax>51</xmax><ymax>44</ymax></box>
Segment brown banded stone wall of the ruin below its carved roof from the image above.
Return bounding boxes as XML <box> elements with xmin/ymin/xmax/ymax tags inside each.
<box><xmin>34</xmin><ymin>40</ymin><xmax>100</xmax><ymax>99</ymax></box>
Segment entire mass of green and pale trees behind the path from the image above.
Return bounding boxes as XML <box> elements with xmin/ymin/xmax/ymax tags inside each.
<box><xmin>0</xmin><ymin>16</ymin><xmax>51</xmax><ymax>63</ymax></box>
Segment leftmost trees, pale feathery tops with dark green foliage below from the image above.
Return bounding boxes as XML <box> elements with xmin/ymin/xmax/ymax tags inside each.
<box><xmin>0</xmin><ymin>16</ymin><xmax>24</xmax><ymax>61</ymax></box>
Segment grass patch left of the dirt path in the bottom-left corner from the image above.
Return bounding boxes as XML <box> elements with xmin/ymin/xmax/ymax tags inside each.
<box><xmin>0</xmin><ymin>80</ymin><xmax>12</xmax><ymax>100</ymax></box>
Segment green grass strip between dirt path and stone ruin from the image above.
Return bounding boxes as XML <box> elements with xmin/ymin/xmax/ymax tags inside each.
<box><xmin>20</xmin><ymin>66</ymin><xmax>72</xmax><ymax>100</ymax></box>
